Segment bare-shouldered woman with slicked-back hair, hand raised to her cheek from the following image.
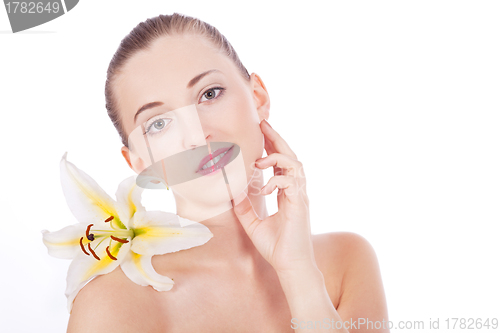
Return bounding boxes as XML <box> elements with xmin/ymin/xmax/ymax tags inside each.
<box><xmin>68</xmin><ymin>14</ymin><xmax>389</xmax><ymax>332</ymax></box>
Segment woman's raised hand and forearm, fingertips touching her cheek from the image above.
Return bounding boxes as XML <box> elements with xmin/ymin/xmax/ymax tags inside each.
<box><xmin>234</xmin><ymin>120</ymin><xmax>348</xmax><ymax>332</ymax></box>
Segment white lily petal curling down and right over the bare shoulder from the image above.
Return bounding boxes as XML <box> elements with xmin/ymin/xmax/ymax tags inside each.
<box><xmin>120</xmin><ymin>251</ymin><xmax>174</xmax><ymax>291</ymax></box>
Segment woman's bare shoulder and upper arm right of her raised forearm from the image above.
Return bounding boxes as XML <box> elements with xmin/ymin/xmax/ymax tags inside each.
<box><xmin>313</xmin><ymin>232</ymin><xmax>388</xmax><ymax>332</ymax></box>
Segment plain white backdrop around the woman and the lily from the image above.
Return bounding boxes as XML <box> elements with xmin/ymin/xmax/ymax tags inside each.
<box><xmin>0</xmin><ymin>0</ymin><xmax>500</xmax><ymax>333</ymax></box>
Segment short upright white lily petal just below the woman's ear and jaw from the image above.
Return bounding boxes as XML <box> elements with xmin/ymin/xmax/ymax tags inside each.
<box><xmin>116</xmin><ymin>176</ymin><xmax>145</xmax><ymax>228</ymax></box>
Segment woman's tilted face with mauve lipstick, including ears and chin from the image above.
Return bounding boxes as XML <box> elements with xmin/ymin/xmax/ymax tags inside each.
<box><xmin>113</xmin><ymin>34</ymin><xmax>269</xmax><ymax>211</ymax></box>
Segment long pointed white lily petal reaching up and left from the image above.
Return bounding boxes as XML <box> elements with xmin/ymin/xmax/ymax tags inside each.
<box><xmin>60</xmin><ymin>153</ymin><xmax>125</xmax><ymax>228</ymax></box>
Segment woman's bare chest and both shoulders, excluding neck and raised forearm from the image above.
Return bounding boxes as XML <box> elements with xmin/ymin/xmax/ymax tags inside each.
<box><xmin>68</xmin><ymin>232</ymin><xmax>389</xmax><ymax>333</ymax></box>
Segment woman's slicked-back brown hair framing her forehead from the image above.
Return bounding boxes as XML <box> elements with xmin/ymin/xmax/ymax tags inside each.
<box><xmin>104</xmin><ymin>13</ymin><xmax>254</xmax><ymax>147</ymax></box>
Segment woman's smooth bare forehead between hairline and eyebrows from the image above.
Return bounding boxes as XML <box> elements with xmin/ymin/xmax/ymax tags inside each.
<box><xmin>114</xmin><ymin>35</ymin><xmax>238</xmax><ymax>127</ymax></box>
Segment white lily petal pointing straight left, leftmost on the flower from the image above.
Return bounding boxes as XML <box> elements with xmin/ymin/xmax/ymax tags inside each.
<box><xmin>42</xmin><ymin>223</ymin><xmax>86</xmax><ymax>259</ymax></box>
